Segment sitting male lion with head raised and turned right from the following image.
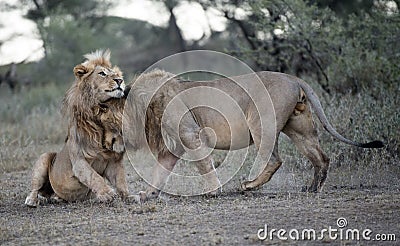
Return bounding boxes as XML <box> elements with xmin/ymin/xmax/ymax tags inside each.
<box><xmin>25</xmin><ymin>50</ymin><xmax>129</xmax><ymax>207</ymax></box>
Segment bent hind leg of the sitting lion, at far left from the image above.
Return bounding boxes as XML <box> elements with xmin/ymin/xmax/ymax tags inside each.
<box><xmin>25</xmin><ymin>152</ymin><xmax>56</xmax><ymax>207</ymax></box>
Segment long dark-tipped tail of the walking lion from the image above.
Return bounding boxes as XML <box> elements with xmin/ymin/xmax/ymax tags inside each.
<box><xmin>298</xmin><ymin>80</ymin><xmax>384</xmax><ymax>148</ymax></box>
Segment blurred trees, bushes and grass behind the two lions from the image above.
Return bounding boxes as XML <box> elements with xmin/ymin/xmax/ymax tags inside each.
<box><xmin>0</xmin><ymin>0</ymin><xmax>400</xmax><ymax>177</ymax></box>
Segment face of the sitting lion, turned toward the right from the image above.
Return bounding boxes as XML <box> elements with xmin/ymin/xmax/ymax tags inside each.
<box><xmin>74</xmin><ymin>63</ymin><xmax>125</xmax><ymax>102</ymax></box>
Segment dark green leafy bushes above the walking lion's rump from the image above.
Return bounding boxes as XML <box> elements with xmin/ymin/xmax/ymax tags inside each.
<box><xmin>239</xmin><ymin>0</ymin><xmax>400</xmax><ymax>94</ymax></box>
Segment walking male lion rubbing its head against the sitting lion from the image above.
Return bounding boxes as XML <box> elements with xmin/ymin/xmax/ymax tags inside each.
<box><xmin>124</xmin><ymin>70</ymin><xmax>383</xmax><ymax>199</ymax></box>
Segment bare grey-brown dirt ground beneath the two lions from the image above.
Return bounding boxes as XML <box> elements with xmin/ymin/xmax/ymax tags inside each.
<box><xmin>0</xmin><ymin>166</ymin><xmax>400</xmax><ymax>245</ymax></box>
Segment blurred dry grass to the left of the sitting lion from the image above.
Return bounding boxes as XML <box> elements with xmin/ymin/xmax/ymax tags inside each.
<box><xmin>0</xmin><ymin>85</ymin><xmax>66</xmax><ymax>172</ymax></box>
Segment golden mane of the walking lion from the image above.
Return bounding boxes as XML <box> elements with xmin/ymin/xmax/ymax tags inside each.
<box><xmin>123</xmin><ymin>69</ymin><xmax>179</xmax><ymax>156</ymax></box>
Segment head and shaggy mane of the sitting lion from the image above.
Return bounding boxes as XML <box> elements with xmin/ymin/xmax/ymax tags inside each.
<box><xmin>63</xmin><ymin>50</ymin><xmax>125</xmax><ymax>158</ymax></box>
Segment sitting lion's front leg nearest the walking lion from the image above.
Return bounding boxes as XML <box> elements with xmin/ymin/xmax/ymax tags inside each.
<box><xmin>104</xmin><ymin>159</ymin><xmax>129</xmax><ymax>199</ymax></box>
